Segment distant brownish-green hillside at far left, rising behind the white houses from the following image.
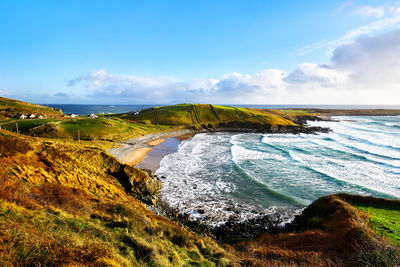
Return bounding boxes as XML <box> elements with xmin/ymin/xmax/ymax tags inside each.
<box><xmin>0</xmin><ymin>97</ymin><xmax>63</xmax><ymax>121</ymax></box>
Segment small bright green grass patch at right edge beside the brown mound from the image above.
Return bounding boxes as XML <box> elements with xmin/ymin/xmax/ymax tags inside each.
<box><xmin>353</xmin><ymin>204</ymin><xmax>400</xmax><ymax>245</ymax></box>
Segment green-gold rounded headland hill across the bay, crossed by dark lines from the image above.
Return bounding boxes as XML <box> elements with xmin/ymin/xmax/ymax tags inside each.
<box><xmin>120</xmin><ymin>104</ymin><xmax>296</xmax><ymax>126</ymax></box>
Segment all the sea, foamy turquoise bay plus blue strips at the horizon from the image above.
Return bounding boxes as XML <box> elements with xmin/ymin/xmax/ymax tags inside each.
<box><xmin>46</xmin><ymin>105</ymin><xmax>400</xmax><ymax>227</ymax></box>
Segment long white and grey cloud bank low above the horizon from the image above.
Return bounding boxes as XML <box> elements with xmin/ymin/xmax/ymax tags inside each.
<box><xmin>68</xmin><ymin>29</ymin><xmax>400</xmax><ymax>104</ymax></box>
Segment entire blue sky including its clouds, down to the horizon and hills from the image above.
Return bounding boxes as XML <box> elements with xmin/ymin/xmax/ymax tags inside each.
<box><xmin>0</xmin><ymin>0</ymin><xmax>400</xmax><ymax>105</ymax></box>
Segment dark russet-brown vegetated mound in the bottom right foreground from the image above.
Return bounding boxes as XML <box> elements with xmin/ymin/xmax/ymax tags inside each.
<box><xmin>237</xmin><ymin>195</ymin><xmax>400</xmax><ymax>266</ymax></box>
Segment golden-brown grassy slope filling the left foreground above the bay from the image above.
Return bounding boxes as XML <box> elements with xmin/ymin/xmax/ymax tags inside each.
<box><xmin>0</xmin><ymin>130</ymin><xmax>235</xmax><ymax>266</ymax></box>
